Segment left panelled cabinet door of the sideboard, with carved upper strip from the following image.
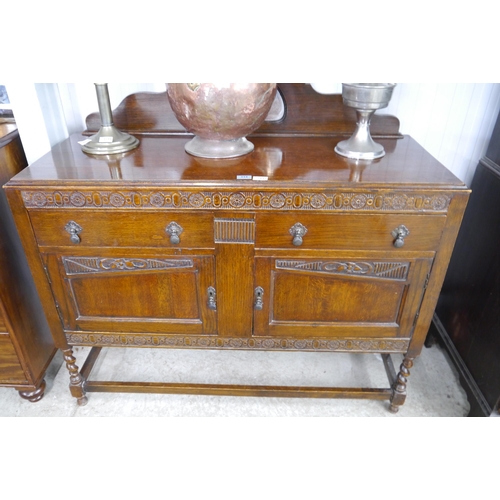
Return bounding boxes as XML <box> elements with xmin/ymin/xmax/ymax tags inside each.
<box><xmin>44</xmin><ymin>254</ymin><xmax>217</xmax><ymax>334</ymax></box>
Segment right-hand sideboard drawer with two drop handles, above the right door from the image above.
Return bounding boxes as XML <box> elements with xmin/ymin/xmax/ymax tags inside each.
<box><xmin>256</xmin><ymin>213</ymin><xmax>446</xmax><ymax>251</ymax></box>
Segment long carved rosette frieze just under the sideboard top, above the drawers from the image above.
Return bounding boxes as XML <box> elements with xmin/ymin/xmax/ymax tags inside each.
<box><xmin>22</xmin><ymin>190</ymin><xmax>451</xmax><ymax>212</ymax></box>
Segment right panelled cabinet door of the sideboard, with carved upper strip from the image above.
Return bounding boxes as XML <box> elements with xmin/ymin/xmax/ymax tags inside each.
<box><xmin>254</xmin><ymin>257</ymin><xmax>432</xmax><ymax>338</ymax></box>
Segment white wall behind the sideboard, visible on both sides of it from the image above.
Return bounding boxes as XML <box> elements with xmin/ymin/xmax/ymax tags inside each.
<box><xmin>6</xmin><ymin>83</ymin><xmax>500</xmax><ymax>184</ymax></box>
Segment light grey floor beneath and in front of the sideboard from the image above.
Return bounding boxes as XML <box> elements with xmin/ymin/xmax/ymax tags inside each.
<box><xmin>0</xmin><ymin>345</ymin><xmax>469</xmax><ymax>418</ymax></box>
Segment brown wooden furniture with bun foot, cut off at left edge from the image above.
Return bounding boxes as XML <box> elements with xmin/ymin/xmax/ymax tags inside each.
<box><xmin>0</xmin><ymin>123</ymin><xmax>56</xmax><ymax>402</ymax></box>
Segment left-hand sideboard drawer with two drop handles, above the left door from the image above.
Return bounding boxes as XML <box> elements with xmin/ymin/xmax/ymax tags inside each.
<box><xmin>30</xmin><ymin>210</ymin><xmax>214</xmax><ymax>248</ymax></box>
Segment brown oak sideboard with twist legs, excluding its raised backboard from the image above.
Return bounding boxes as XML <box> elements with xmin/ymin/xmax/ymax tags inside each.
<box><xmin>2</xmin><ymin>86</ymin><xmax>469</xmax><ymax>411</ymax></box>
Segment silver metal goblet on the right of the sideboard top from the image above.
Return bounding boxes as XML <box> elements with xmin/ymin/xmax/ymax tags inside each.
<box><xmin>335</xmin><ymin>83</ymin><xmax>396</xmax><ymax>160</ymax></box>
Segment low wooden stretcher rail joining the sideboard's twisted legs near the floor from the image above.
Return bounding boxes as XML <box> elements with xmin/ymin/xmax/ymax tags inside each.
<box><xmin>72</xmin><ymin>347</ymin><xmax>402</xmax><ymax>411</ymax></box>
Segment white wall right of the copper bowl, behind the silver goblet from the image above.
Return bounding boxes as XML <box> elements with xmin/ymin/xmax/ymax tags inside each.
<box><xmin>312</xmin><ymin>83</ymin><xmax>500</xmax><ymax>185</ymax></box>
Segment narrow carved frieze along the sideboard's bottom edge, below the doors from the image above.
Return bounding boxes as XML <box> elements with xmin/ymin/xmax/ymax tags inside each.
<box><xmin>66</xmin><ymin>333</ymin><xmax>410</xmax><ymax>352</ymax></box>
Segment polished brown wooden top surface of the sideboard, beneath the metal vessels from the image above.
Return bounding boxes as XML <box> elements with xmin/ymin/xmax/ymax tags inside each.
<box><xmin>9</xmin><ymin>134</ymin><xmax>466</xmax><ymax>189</ymax></box>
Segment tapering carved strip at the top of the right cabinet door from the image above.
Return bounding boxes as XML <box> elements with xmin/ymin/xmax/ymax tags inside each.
<box><xmin>275</xmin><ymin>259</ymin><xmax>410</xmax><ymax>280</ymax></box>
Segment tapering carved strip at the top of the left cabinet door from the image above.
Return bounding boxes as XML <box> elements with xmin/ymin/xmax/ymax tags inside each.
<box><xmin>62</xmin><ymin>257</ymin><xmax>193</xmax><ymax>274</ymax></box>
